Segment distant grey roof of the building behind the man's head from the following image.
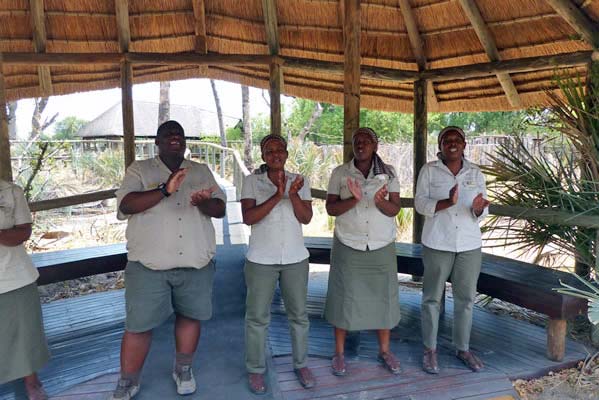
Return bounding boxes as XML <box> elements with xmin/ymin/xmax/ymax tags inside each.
<box><xmin>77</xmin><ymin>101</ymin><xmax>239</xmax><ymax>139</ymax></box>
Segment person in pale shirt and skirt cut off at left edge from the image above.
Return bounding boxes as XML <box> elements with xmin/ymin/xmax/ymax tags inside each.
<box><xmin>0</xmin><ymin>180</ymin><xmax>50</xmax><ymax>400</ymax></box>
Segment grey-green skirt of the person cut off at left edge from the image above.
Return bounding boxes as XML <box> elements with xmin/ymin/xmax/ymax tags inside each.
<box><xmin>0</xmin><ymin>283</ymin><xmax>50</xmax><ymax>384</ymax></box>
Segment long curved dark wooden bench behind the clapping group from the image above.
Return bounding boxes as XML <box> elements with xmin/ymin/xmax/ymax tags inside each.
<box><xmin>31</xmin><ymin>237</ymin><xmax>587</xmax><ymax>361</ymax></box>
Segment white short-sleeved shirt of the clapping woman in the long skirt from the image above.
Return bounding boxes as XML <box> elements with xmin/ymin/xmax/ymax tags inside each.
<box><xmin>327</xmin><ymin>160</ymin><xmax>399</xmax><ymax>251</ymax></box>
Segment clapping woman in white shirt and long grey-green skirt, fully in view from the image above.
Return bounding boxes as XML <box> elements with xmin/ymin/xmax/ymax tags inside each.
<box><xmin>324</xmin><ymin>128</ymin><xmax>400</xmax><ymax>376</ymax></box>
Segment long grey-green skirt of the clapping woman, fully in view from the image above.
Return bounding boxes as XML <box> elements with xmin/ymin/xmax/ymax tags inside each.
<box><xmin>324</xmin><ymin>237</ymin><xmax>400</xmax><ymax>331</ymax></box>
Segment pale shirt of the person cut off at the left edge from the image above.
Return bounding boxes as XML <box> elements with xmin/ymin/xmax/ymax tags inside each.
<box><xmin>0</xmin><ymin>180</ymin><xmax>39</xmax><ymax>294</ymax></box>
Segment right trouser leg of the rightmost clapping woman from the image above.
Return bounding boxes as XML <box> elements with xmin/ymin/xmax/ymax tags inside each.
<box><xmin>451</xmin><ymin>248</ymin><xmax>482</xmax><ymax>351</ymax></box>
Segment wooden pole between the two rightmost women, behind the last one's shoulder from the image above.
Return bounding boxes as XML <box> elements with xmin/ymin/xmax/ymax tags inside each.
<box><xmin>412</xmin><ymin>80</ymin><xmax>428</xmax><ymax>243</ymax></box>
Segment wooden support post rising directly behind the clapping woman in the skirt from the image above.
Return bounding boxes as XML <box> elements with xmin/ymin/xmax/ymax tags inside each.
<box><xmin>343</xmin><ymin>0</ymin><xmax>361</xmax><ymax>162</ymax></box>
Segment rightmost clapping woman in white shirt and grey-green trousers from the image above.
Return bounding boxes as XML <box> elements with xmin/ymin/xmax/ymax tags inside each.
<box><xmin>414</xmin><ymin>126</ymin><xmax>489</xmax><ymax>374</ymax></box>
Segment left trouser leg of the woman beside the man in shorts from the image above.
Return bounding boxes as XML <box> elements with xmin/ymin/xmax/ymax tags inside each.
<box><xmin>244</xmin><ymin>261</ymin><xmax>280</xmax><ymax>374</ymax></box>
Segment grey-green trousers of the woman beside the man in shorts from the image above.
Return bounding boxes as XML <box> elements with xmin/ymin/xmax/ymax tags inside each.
<box><xmin>244</xmin><ymin>259</ymin><xmax>310</xmax><ymax>374</ymax></box>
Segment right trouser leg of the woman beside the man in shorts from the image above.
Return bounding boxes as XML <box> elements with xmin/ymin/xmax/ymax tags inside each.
<box><xmin>279</xmin><ymin>260</ymin><xmax>310</xmax><ymax>369</ymax></box>
